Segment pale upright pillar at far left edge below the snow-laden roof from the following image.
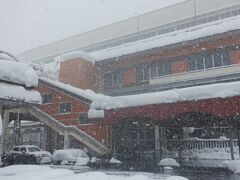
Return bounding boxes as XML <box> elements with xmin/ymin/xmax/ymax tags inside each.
<box><xmin>0</xmin><ymin>111</ymin><xmax>9</xmax><ymax>154</ymax></box>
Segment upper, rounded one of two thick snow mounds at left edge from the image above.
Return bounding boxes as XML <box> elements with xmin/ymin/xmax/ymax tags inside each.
<box><xmin>0</xmin><ymin>60</ymin><xmax>38</xmax><ymax>87</ymax></box>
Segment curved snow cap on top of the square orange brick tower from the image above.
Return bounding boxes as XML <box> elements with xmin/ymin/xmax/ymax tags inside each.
<box><xmin>54</xmin><ymin>51</ymin><xmax>97</xmax><ymax>64</ymax></box>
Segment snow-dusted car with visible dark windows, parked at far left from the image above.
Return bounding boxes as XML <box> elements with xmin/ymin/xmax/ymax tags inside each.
<box><xmin>2</xmin><ymin>145</ymin><xmax>52</xmax><ymax>166</ymax></box>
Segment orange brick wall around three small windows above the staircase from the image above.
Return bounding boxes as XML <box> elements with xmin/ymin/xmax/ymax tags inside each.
<box><xmin>37</xmin><ymin>83</ymin><xmax>107</xmax><ymax>146</ymax></box>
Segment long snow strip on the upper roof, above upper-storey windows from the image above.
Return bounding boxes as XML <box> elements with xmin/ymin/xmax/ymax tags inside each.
<box><xmin>90</xmin><ymin>16</ymin><xmax>240</xmax><ymax>61</ymax></box>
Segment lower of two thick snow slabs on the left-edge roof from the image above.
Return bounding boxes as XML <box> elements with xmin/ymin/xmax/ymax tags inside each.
<box><xmin>0</xmin><ymin>83</ymin><xmax>41</xmax><ymax>104</ymax></box>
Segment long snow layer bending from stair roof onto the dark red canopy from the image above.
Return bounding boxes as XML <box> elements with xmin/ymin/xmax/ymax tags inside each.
<box><xmin>40</xmin><ymin>77</ymin><xmax>240</xmax><ymax>118</ymax></box>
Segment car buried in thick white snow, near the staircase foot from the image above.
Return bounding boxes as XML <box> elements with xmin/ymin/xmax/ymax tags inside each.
<box><xmin>52</xmin><ymin>149</ymin><xmax>90</xmax><ymax>166</ymax></box>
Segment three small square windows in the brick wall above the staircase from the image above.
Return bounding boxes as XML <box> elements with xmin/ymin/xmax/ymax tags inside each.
<box><xmin>42</xmin><ymin>94</ymin><xmax>91</xmax><ymax>124</ymax></box>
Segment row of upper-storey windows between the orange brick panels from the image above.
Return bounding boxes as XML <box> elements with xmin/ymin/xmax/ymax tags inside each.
<box><xmin>104</xmin><ymin>49</ymin><xmax>231</xmax><ymax>87</ymax></box>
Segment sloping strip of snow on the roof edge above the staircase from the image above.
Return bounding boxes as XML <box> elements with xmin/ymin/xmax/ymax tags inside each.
<box><xmin>39</xmin><ymin>77</ymin><xmax>109</xmax><ymax>103</ymax></box>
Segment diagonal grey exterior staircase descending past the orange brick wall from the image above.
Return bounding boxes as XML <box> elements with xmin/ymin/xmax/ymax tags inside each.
<box><xmin>27</xmin><ymin>106</ymin><xmax>110</xmax><ymax>156</ymax></box>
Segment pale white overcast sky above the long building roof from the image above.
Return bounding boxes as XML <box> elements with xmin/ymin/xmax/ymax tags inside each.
<box><xmin>0</xmin><ymin>0</ymin><xmax>184</xmax><ymax>54</ymax></box>
